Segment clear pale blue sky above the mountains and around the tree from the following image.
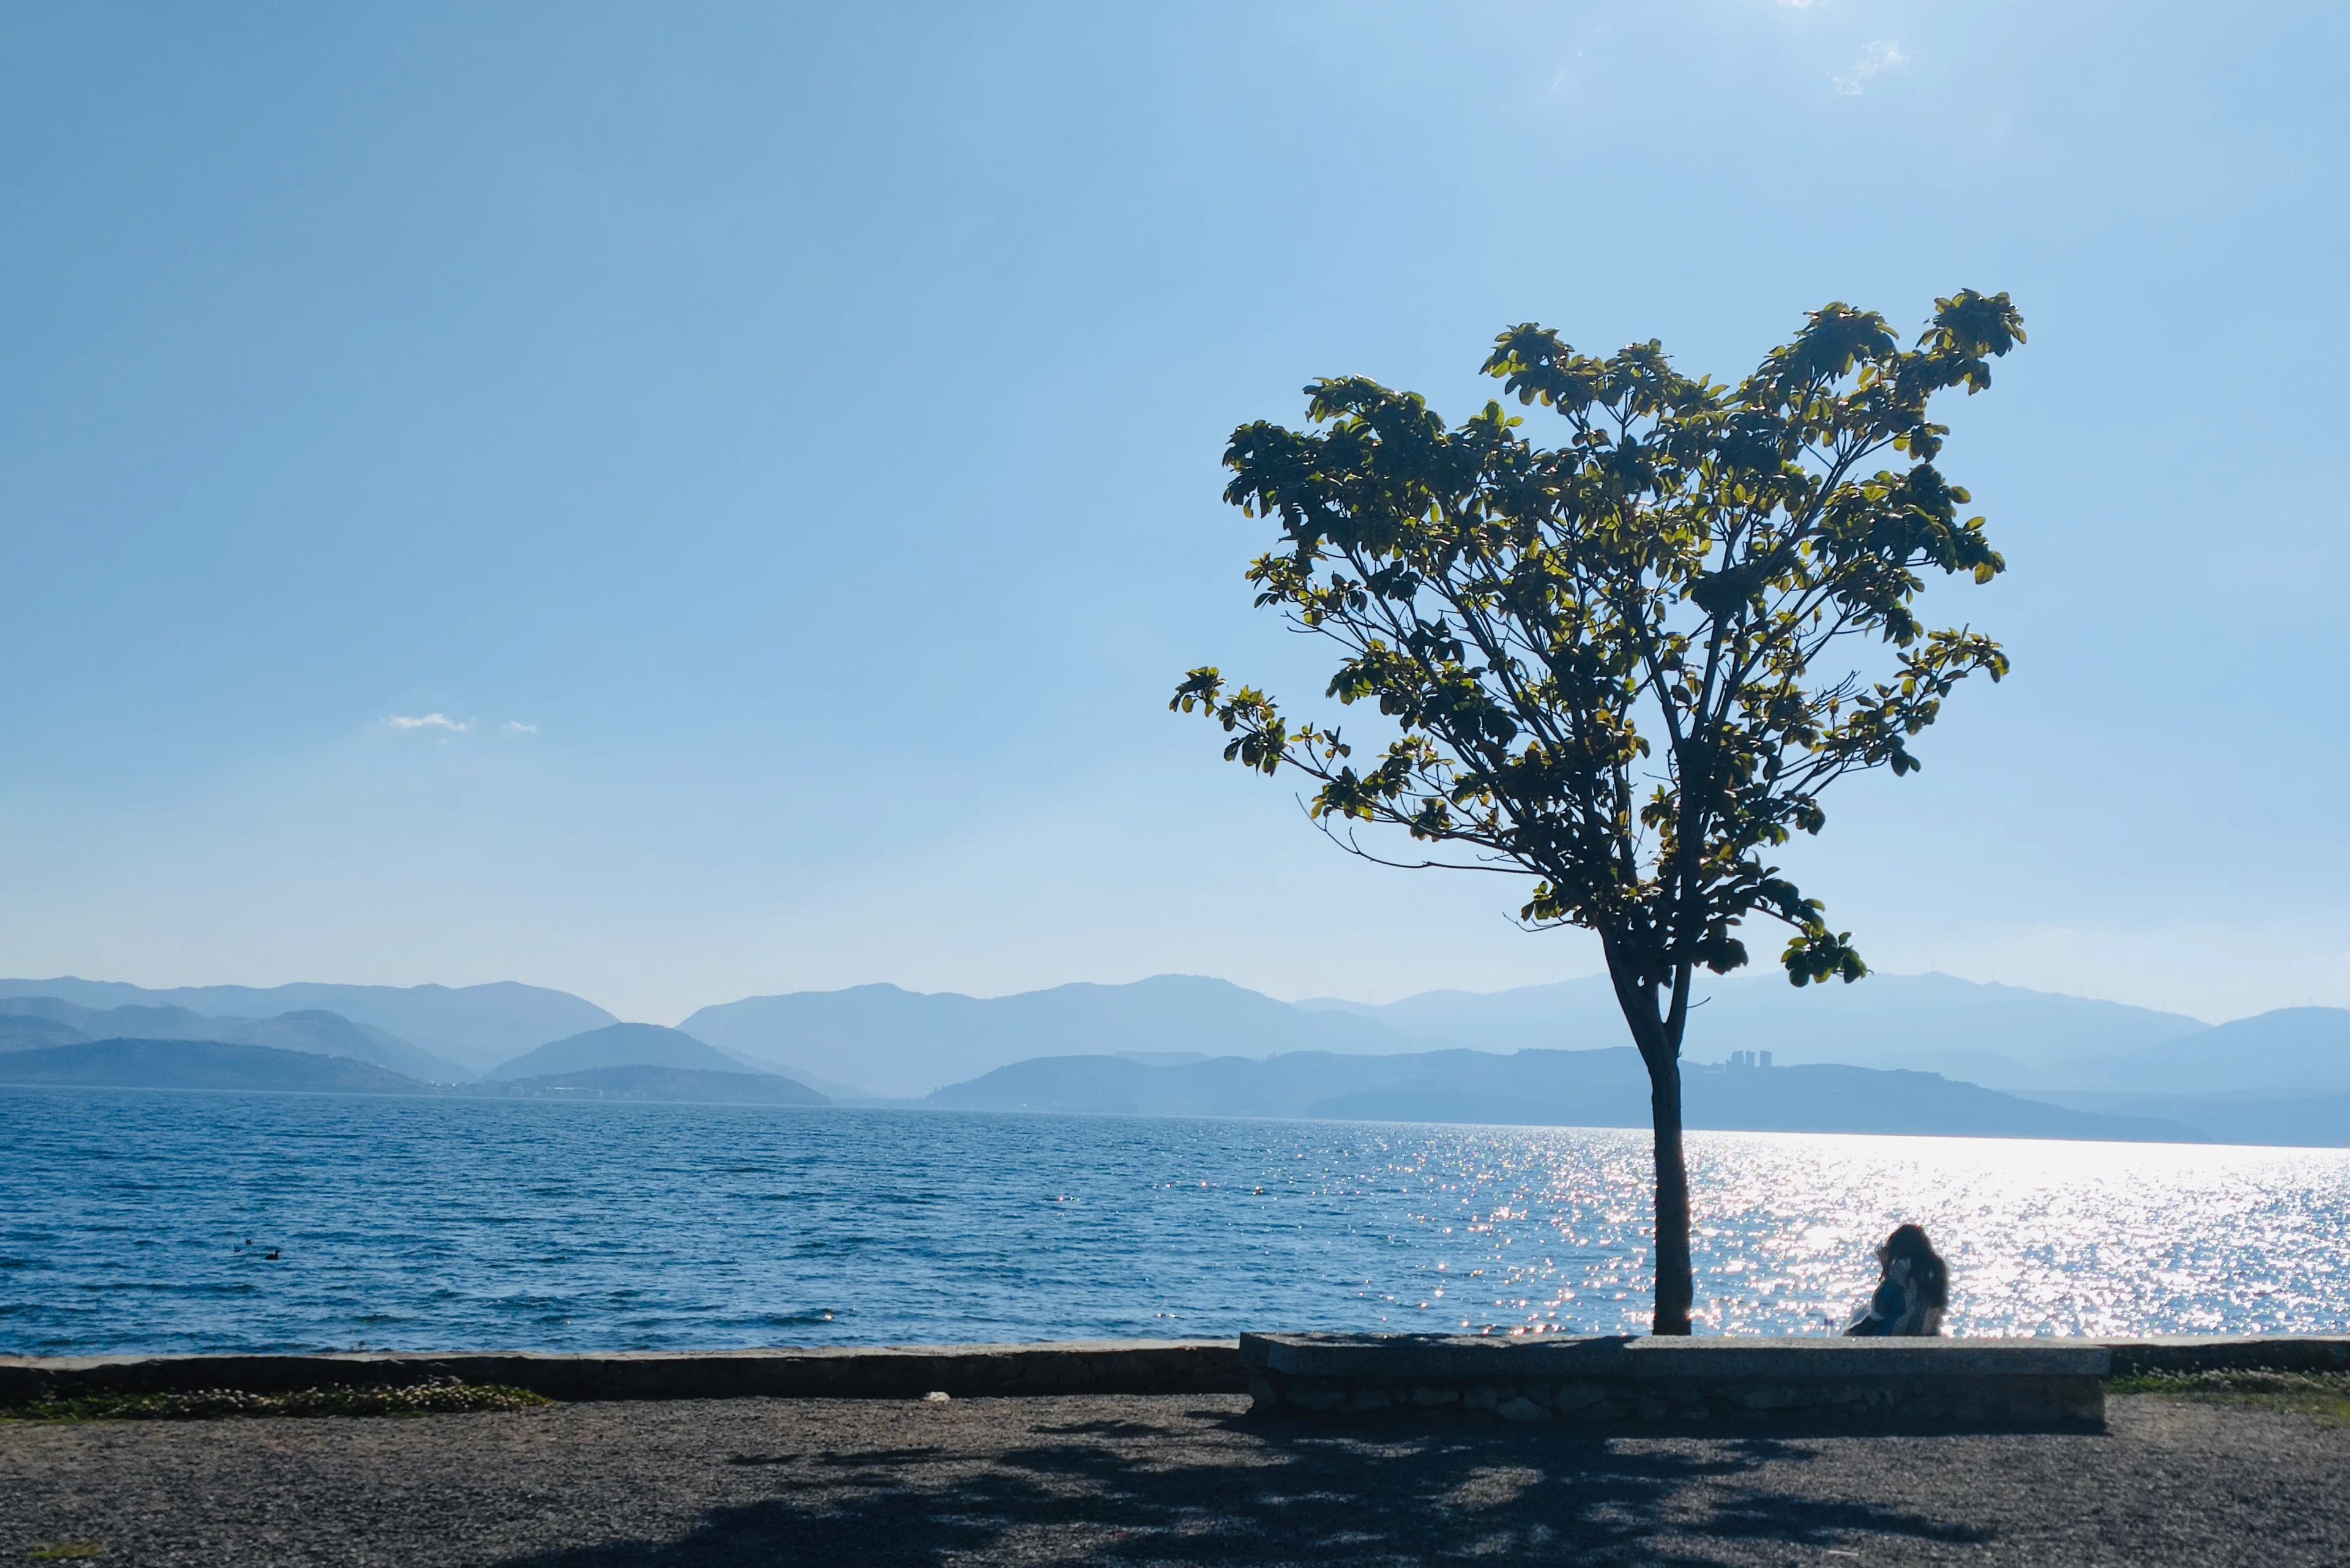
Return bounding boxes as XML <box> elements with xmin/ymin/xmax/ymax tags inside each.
<box><xmin>0</xmin><ymin>0</ymin><xmax>2350</xmax><ymax>1023</ymax></box>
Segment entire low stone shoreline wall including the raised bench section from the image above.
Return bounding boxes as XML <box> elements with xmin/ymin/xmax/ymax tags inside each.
<box><xmin>0</xmin><ymin>1333</ymin><xmax>2350</xmax><ymax>1429</ymax></box>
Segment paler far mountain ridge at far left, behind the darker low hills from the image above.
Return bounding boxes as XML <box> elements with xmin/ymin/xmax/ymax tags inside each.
<box><xmin>0</xmin><ymin>978</ymin><xmax>613</xmax><ymax>1070</ymax></box>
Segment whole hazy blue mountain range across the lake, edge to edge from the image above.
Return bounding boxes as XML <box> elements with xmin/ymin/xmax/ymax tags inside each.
<box><xmin>0</xmin><ymin>976</ymin><xmax>2350</xmax><ymax>1143</ymax></box>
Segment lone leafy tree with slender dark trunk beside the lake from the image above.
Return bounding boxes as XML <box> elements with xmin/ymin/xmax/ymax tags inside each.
<box><xmin>1170</xmin><ymin>289</ymin><xmax>2023</xmax><ymax>1335</ymax></box>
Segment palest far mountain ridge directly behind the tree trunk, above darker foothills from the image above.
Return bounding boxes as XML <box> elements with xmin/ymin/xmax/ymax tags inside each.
<box><xmin>1300</xmin><ymin>973</ymin><xmax>2207</xmax><ymax>1081</ymax></box>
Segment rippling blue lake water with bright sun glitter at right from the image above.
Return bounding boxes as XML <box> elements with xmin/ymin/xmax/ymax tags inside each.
<box><xmin>0</xmin><ymin>1088</ymin><xmax>2350</xmax><ymax>1354</ymax></box>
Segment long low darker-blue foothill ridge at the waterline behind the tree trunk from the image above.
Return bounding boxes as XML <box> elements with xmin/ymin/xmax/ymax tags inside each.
<box><xmin>931</xmin><ymin>1046</ymin><xmax>2195</xmax><ymax>1143</ymax></box>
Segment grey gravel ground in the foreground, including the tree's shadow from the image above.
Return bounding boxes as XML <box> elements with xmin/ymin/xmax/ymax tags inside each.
<box><xmin>0</xmin><ymin>1397</ymin><xmax>2350</xmax><ymax>1568</ymax></box>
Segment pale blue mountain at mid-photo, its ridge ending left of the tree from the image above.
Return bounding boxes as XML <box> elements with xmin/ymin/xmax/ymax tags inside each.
<box><xmin>679</xmin><ymin>976</ymin><xmax>1417</xmax><ymax>1098</ymax></box>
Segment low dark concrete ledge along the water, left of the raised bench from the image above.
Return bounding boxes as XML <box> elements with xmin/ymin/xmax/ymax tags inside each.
<box><xmin>0</xmin><ymin>1340</ymin><xmax>1245</xmax><ymax>1406</ymax></box>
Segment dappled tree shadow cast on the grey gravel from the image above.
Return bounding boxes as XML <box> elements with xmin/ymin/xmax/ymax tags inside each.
<box><xmin>512</xmin><ymin>1413</ymin><xmax>1986</xmax><ymax>1568</ymax></box>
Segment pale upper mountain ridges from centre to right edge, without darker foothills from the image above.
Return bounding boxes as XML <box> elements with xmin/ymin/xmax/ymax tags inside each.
<box><xmin>679</xmin><ymin>973</ymin><xmax>2350</xmax><ymax>1098</ymax></box>
